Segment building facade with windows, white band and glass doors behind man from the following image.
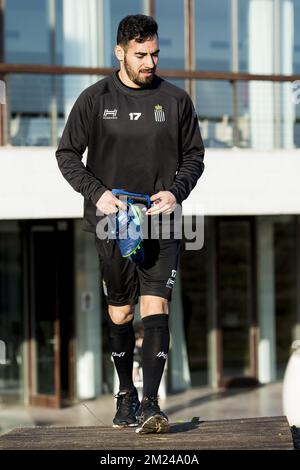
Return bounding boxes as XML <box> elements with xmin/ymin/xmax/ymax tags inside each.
<box><xmin>0</xmin><ymin>0</ymin><xmax>300</xmax><ymax>406</ymax></box>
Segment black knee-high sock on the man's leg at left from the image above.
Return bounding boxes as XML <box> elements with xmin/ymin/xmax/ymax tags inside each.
<box><xmin>109</xmin><ymin>317</ymin><xmax>135</xmax><ymax>391</ymax></box>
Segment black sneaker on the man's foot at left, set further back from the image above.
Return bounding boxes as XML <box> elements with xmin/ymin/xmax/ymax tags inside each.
<box><xmin>113</xmin><ymin>388</ymin><xmax>140</xmax><ymax>428</ymax></box>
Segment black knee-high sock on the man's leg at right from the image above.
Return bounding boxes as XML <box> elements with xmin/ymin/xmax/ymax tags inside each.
<box><xmin>142</xmin><ymin>313</ymin><xmax>170</xmax><ymax>397</ymax></box>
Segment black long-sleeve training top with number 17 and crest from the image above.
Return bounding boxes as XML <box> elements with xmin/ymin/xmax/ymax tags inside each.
<box><xmin>56</xmin><ymin>72</ymin><xmax>204</xmax><ymax>231</ymax></box>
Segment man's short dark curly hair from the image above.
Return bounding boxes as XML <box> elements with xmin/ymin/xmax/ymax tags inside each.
<box><xmin>117</xmin><ymin>15</ymin><xmax>158</xmax><ymax>46</ymax></box>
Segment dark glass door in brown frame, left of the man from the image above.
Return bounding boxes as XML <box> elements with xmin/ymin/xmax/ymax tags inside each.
<box><xmin>29</xmin><ymin>224</ymin><xmax>61</xmax><ymax>407</ymax></box>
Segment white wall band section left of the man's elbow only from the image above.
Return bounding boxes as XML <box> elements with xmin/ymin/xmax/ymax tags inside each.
<box><xmin>0</xmin><ymin>147</ymin><xmax>82</xmax><ymax>219</ymax></box>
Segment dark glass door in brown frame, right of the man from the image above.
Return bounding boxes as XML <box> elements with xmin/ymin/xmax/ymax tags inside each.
<box><xmin>217</xmin><ymin>218</ymin><xmax>257</xmax><ymax>386</ymax></box>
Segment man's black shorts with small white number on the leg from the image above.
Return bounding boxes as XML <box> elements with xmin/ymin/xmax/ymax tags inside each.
<box><xmin>95</xmin><ymin>236</ymin><xmax>181</xmax><ymax>306</ymax></box>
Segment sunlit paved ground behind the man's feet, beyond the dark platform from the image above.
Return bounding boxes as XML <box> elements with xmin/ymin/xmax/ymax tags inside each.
<box><xmin>0</xmin><ymin>382</ymin><xmax>283</xmax><ymax>434</ymax></box>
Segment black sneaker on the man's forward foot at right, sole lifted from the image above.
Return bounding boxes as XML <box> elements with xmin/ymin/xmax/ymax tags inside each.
<box><xmin>135</xmin><ymin>397</ymin><xmax>169</xmax><ymax>434</ymax></box>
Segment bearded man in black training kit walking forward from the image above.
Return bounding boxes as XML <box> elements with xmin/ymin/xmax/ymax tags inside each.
<box><xmin>56</xmin><ymin>15</ymin><xmax>204</xmax><ymax>433</ymax></box>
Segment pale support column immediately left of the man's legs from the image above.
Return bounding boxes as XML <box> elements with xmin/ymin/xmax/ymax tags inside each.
<box><xmin>74</xmin><ymin>221</ymin><xmax>102</xmax><ymax>399</ymax></box>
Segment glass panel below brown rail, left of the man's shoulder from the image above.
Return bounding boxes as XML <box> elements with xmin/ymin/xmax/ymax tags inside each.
<box><xmin>8</xmin><ymin>74</ymin><xmax>102</xmax><ymax>146</ymax></box>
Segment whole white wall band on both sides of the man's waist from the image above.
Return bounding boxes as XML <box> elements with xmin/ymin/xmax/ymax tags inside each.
<box><xmin>0</xmin><ymin>147</ymin><xmax>300</xmax><ymax>219</ymax></box>
